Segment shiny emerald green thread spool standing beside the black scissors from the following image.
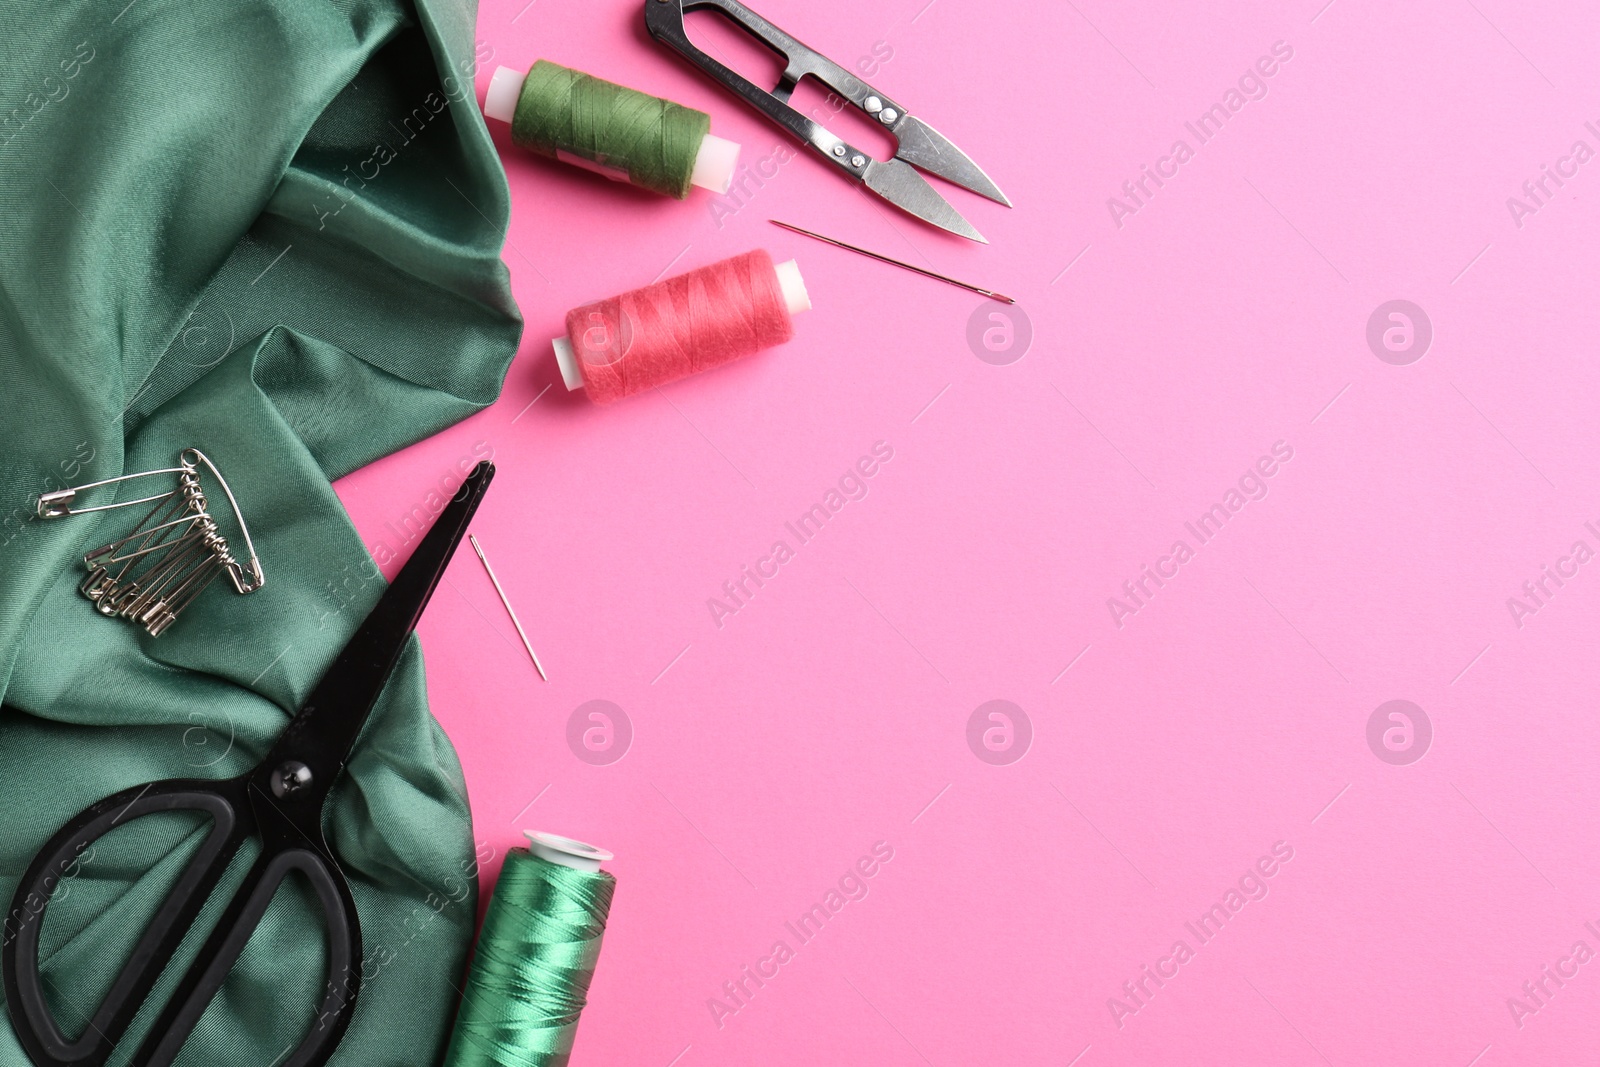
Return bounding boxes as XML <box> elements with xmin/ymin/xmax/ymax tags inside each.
<box><xmin>445</xmin><ymin>830</ymin><xmax>616</xmax><ymax>1067</ymax></box>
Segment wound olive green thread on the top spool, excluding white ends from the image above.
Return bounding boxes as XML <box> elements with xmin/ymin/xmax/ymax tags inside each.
<box><xmin>510</xmin><ymin>59</ymin><xmax>710</xmax><ymax>200</ymax></box>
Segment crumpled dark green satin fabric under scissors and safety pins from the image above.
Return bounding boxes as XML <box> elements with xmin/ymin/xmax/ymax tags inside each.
<box><xmin>0</xmin><ymin>0</ymin><xmax>522</xmax><ymax>1067</ymax></box>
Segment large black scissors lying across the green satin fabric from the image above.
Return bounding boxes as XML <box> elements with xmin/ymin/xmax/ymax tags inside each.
<box><xmin>0</xmin><ymin>462</ymin><xmax>494</xmax><ymax>1067</ymax></box>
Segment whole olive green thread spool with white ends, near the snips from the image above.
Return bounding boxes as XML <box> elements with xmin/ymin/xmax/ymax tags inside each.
<box><xmin>483</xmin><ymin>59</ymin><xmax>739</xmax><ymax>200</ymax></box>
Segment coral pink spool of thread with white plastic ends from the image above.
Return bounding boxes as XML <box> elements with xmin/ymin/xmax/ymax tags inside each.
<box><xmin>550</xmin><ymin>248</ymin><xmax>811</xmax><ymax>403</ymax></box>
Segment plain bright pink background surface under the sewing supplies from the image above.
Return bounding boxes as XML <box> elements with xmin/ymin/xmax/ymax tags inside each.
<box><xmin>339</xmin><ymin>0</ymin><xmax>1600</xmax><ymax>1067</ymax></box>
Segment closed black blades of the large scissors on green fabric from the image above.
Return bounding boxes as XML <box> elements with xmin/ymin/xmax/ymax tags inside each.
<box><xmin>258</xmin><ymin>462</ymin><xmax>494</xmax><ymax>790</ymax></box>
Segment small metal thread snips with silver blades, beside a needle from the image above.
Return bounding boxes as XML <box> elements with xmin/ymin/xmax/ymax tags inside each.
<box><xmin>645</xmin><ymin>0</ymin><xmax>1011</xmax><ymax>245</ymax></box>
